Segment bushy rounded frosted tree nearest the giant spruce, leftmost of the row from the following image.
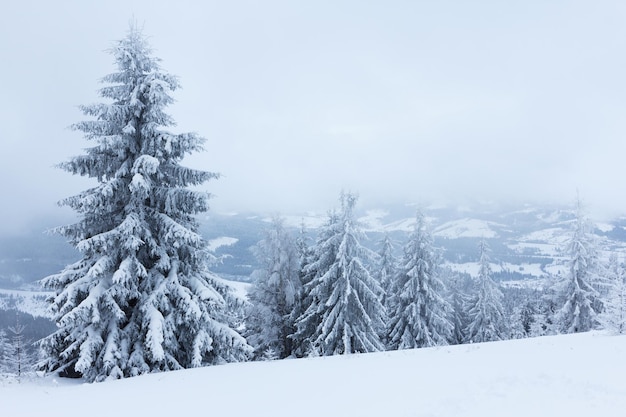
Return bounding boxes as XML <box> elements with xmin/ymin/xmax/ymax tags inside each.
<box><xmin>246</xmin><ymin>217</ymin><xmax>301</xmax><ymax>359</ymax></box>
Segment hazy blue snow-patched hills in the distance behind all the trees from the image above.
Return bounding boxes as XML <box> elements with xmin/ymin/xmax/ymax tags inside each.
<box><xmin>0</xmin><ymin>204</ymin><xmax>626</xmax><ymax>289</ymax></box>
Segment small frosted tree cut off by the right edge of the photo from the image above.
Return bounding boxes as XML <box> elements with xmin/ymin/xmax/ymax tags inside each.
<box><xmin>600</xmin><ymin>253</ymin><xmax>626</xmax><ymax>334</ymax></box>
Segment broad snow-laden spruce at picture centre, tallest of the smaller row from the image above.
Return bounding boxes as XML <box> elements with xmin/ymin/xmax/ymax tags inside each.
<box><xmin>294</xmin><ymin>194</ymin><xmax>385</xmax><ymax>356</ymax></box>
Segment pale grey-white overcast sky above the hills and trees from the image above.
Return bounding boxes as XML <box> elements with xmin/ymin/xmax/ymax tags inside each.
<box><xmin>0</xmin><ymin>0</ymin><xmax>626</xmax><ymax>232</ymax></box>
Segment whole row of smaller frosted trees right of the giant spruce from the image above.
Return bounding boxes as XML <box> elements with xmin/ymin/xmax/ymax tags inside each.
<box><xmin>240</xmin><ymin>194</ymin><xmax>626</xmax><ymax>359</ymax></box>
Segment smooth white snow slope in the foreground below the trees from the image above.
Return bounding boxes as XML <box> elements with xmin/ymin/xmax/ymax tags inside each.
<box><xmin>0</xmin><ymin>333</ymin><xmax>626</xmax><ymax>417</ymax></box>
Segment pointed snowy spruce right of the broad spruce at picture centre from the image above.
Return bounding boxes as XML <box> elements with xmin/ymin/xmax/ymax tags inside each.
<box><xmin>388</xmin><ymin>212</ymin><xmax>453</xmax><ymax>349</ymax></box>
